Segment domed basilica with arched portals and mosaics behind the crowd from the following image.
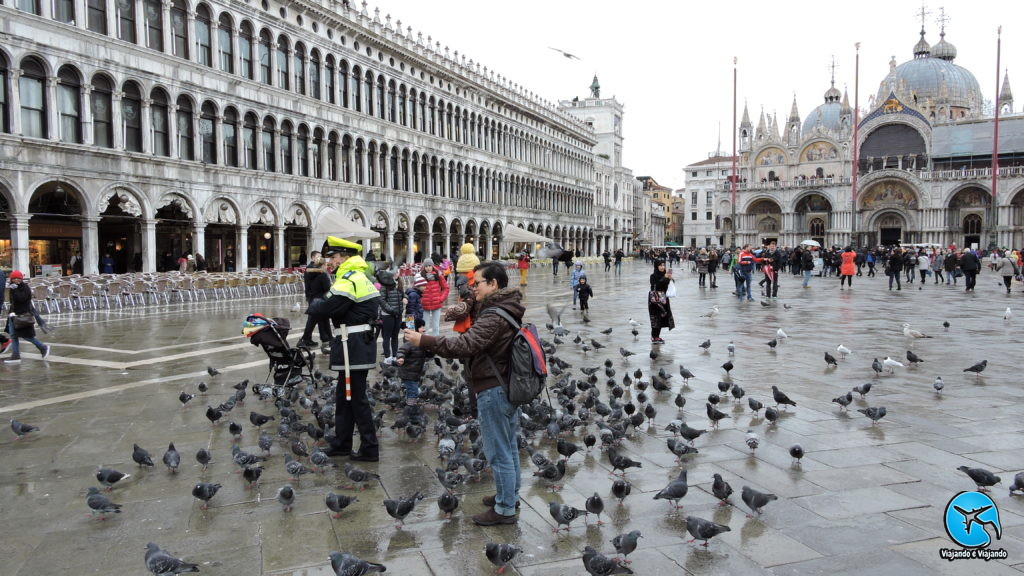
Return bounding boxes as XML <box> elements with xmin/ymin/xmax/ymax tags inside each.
<box><xmin>716</xmin><ymin>21</ymin><xmax>1024</xmax><ymax>248</ymax></box>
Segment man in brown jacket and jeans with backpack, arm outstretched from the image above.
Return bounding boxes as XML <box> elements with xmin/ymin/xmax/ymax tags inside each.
<box><xmin>404</xmin><ymin>261</ymin><xmax>525</xmax><ymax>526</ymax></box>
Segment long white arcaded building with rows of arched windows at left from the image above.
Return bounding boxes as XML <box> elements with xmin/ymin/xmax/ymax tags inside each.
<box><xmin>0</xmin><ymin>0</ymin><xmax>598</xmax><ymax>273</ymax></box>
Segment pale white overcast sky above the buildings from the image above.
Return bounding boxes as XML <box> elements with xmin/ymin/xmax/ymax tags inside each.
<box><xmin>376</xmin><ymin>0</ymin><xmax>1024</xmax><ymax>188</ymax></box>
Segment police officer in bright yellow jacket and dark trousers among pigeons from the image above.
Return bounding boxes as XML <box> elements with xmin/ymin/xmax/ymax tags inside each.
<box><xmin>310</xmin><ymin>236</ymin><xmax>380</xmax><ymax>462</ymax></box>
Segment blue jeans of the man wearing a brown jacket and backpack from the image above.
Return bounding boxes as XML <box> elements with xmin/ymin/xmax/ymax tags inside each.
<box><xmin>476</xmin><ymin>386</ymin><xmax>520</xmax><ymax>516</ymax></box>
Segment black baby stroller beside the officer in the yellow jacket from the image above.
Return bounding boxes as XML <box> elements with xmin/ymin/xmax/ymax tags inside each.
<box><xmin>242</xmin><ymin>313</ymin><xmax>316</xmax><ymax>398</ymax></box>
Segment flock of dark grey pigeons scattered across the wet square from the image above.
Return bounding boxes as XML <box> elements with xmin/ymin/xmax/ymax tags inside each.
<box><xmin>10</xmin><ymin>291</ymin><xmax>1024</xmax><ymax>576</ymax></box>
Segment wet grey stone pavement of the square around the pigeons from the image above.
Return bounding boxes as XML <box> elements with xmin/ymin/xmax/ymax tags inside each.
<box><xmin>0</xmin><ymin>262</ymin><xmax>1024</xmax><ymax>576</ymax></box>
